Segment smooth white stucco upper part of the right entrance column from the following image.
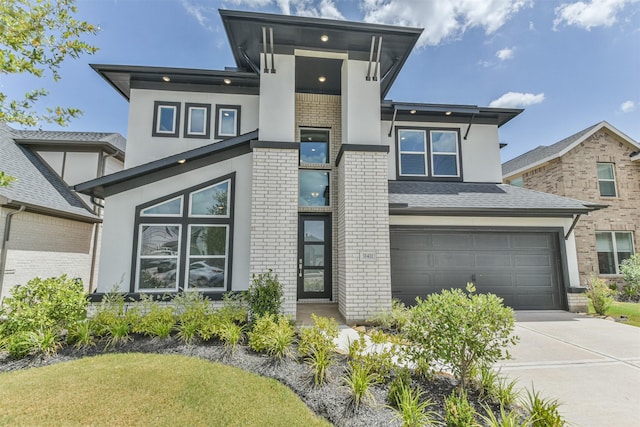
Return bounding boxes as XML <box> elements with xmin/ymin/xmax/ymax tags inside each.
<box><xmin>342</xmin><ymin>60</ymin><xmax>380</xmax><ymax>145</ymax></box>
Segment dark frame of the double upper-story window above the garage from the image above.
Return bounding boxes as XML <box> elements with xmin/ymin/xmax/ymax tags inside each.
<box><xmin>395</xmin><ymin>126</ymin><xmax>464</xmax><ymax>182</ymax></box>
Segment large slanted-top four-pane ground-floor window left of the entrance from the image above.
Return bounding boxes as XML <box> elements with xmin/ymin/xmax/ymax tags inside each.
<box><xmin>132</xmin><ymin>174</ymin><xmax>235</xmax><ymax>292</ymax></box>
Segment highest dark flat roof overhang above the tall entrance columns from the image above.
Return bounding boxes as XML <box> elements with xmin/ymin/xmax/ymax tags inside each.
<box><xmin>219</xmin><ymin>10</ymin><xmax>422</xmax><ymax>98</ymax></box>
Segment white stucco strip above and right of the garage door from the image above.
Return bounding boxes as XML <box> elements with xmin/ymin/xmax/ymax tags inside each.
<box><xmin>389</xmin><ymin>215</ymin><xmax>580</xmax><ymax>288</ymax></box>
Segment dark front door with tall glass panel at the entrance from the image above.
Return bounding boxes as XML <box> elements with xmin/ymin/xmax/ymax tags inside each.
<box><xmin>298</xmin><ymin>214</ymin><xmax>331</xmax><ymax>299</ymax></box>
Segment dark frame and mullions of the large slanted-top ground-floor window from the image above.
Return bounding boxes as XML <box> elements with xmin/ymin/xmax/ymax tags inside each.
<box><xmin>129</xmin><ymin>172</ymin><xmax>236</xmax><ymax>299</ymax></box>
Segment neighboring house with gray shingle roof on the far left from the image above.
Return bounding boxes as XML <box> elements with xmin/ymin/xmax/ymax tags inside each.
<box><xmin>0</xmin><ymin>123</ymin><xmax>125</xmax><ymax>301</ymax></box>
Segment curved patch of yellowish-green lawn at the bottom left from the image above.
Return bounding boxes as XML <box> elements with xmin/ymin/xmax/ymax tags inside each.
<box><xmin>0</xmin><ymin>354</ymin><xmax>330</xmax><ymax>426</ymax></box>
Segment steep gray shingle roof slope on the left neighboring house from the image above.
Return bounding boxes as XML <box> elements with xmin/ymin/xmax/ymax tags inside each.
<box><xmin>0</xmin><ymin>123</ymin><xmax>99</xmax><ymax>221</ymax></box>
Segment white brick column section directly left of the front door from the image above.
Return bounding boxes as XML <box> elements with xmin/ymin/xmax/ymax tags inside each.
<box><xmin>249</xmin><ymin>148</ymin><xmax>298</xmax><ymax>317</ymax></box>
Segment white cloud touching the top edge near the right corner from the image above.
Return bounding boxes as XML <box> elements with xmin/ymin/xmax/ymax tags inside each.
<box><xmin>553</xmin><ymin>0</ymin><xmax>637</xmax><ymax>30</ymax></box>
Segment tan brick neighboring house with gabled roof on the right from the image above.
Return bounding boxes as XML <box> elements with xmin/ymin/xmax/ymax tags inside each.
<box><xmin>502</xmin><ymin>122</ymin><xmax>640</xmax><ymax>285</ymax></box>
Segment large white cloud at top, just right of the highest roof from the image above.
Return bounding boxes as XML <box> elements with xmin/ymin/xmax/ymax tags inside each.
<box><xmin>360</xmin><ymin>0</ymin><xmax>531</xmax><ymax>46</ymax></box>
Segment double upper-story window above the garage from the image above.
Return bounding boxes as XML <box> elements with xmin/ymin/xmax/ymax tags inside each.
<box><xmin>397</xmin><ymin>129</ymin><xmax>461</xmax><ymax>180</ymax></box>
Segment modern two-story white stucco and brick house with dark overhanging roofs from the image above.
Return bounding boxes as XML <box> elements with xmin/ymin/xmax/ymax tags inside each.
<box><xmin>75</xmin><ymin>10</ymin><xmax>597</xmax><ymax>321</ymax></box>
